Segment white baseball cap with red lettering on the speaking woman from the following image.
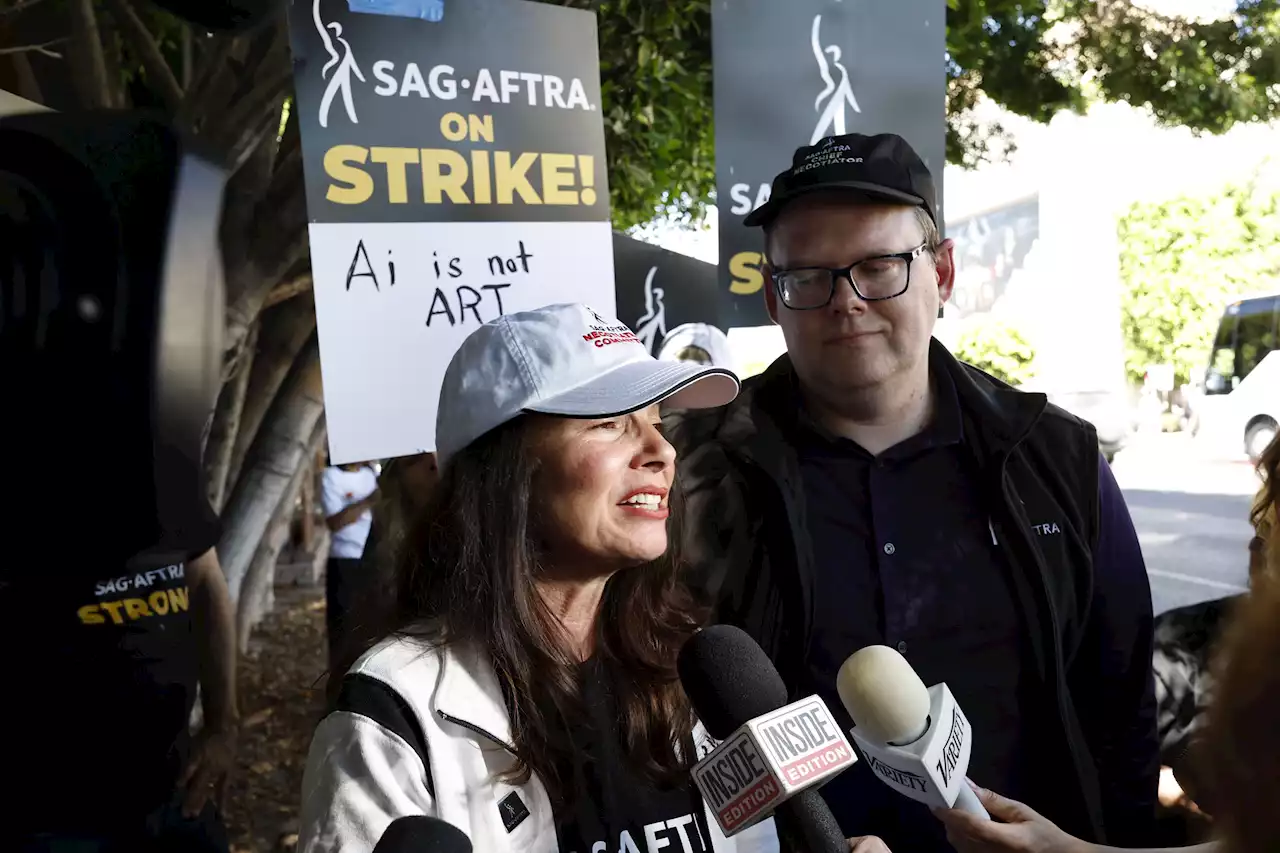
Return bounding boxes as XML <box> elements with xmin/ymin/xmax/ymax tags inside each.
<box><xmin>435</xmin><ymin>304</ymin><xmax>737</xmax><ymax>469</ymax></box>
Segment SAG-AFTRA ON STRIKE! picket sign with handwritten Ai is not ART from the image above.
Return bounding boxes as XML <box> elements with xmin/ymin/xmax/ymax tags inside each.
<box><xmin>289</xmin><ymin>0</ymin><xmax>614</xmax><ymax>464</ymax></box>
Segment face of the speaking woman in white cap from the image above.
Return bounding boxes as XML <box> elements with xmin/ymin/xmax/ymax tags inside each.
<box><xmin>534</xmin><ymin>406</ymin><xmax>676</xmax><ymax>574</ymax></box>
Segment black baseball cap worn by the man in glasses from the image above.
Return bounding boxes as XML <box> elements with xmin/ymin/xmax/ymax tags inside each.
<box><xmin>742</xmin><ymin>133</ymin><xmax>938</xmax><ymax>225</ymax></box>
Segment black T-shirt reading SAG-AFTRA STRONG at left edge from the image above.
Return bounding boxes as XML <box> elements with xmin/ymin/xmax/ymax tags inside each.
<box><xmin>0</xmin><ymin>507</ymin><xmax>219</xmax><ymax>836</ymax></box>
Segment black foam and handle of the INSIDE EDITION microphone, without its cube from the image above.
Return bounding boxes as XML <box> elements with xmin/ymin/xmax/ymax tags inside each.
<box><xmin>676</xmin><ymin>625</ymin><xmax>849</xmax><ymax>853</ymax></box>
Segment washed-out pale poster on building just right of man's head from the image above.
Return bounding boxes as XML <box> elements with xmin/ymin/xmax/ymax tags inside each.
<box><xmin>947</xmin><ymin>195</ymin><xmax>1039</xmax><ymax>319</ymax></box>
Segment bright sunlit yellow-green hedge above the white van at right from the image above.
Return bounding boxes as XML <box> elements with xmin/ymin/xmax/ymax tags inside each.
<box><xmin>1120</xmin><ymin>186</ymin><xmax>1280</xmax><ymax>384</ymax></box>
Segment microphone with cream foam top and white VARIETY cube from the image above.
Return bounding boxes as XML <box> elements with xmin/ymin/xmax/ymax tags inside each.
<box><xmin>836</xmin><ymin>646</ymin><xmax>991</xmax><ymax>820</ymax></box>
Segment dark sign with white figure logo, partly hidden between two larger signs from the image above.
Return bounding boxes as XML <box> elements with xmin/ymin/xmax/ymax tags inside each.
<box><xmin>613</xmin><ymin>233</ymin><xmax>723</xmax><ymax>356</ymax></box>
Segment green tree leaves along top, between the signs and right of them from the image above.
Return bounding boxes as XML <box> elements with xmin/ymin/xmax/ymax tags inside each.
<box><xmin>576</xmin><ymin>0</ymin><xmax>1280</xmax><ymax>229</ymax></box>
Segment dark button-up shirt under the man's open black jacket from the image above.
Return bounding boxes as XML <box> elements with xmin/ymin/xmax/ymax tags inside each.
<box><xmin>790</xmin><ymin>371</ymin><xmax>1032</xmax><ymax>852</ymax></box>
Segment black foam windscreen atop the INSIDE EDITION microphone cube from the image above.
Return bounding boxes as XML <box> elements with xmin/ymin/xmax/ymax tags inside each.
<box><xmin>676</xmin><ymin>625</ymin><xmax>787</xmax><ymax>740</ymax></box>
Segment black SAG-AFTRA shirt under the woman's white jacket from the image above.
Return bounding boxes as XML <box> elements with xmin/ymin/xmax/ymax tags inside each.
<box><xmin>556</xmin><ymin>658</ymin><xmax>710</xmax><ymax>853</ymax></box>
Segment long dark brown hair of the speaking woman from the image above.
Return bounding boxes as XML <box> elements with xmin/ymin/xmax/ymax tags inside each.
<box><xmin>363</xmin><ymin>416</ymin><xmax>705</xmax><ymax>808</ymax></box>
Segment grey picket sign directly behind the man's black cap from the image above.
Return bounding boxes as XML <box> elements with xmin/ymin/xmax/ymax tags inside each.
<box><xmin>712</xmin><ymin>0</ymin><xmax>946</xmax><ymax>327</ymax></box>
